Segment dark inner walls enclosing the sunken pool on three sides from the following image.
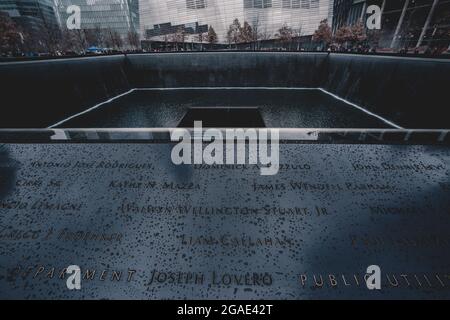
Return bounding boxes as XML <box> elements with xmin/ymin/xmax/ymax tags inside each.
<box><xmin>0</xmin><ymin>52</ymin><xmax>450</xmax><ymax>128</ymax></box>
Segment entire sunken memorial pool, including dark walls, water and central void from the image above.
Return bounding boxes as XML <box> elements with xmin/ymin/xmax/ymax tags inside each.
<box><xmin>0</xmin><ymin>52</ymin><xmax>450</xmax><ymax>129</ymax></box>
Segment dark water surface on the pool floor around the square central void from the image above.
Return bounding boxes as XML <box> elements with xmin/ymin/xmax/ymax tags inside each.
<box><xmin>51</xmin><ymin>88</ymin><xmax>396</xmax><ymax>128</ymax></box>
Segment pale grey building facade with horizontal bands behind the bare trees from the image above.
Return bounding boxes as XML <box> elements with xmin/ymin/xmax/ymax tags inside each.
<box><xmin>139</xmin><ymin>0</ymin><xmax>333</xmax><ymax>43</ymax></box>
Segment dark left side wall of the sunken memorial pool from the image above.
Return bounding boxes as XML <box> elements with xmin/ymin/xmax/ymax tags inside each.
<box><xmin>0</xmin><ymin>55</ymin><xmax>131</xmax><ymax>128</ymax></box>
